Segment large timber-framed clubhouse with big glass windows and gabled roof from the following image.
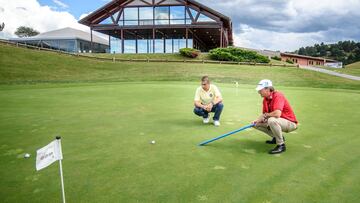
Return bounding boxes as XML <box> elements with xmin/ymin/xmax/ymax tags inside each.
<box><xmin>79</xmin><ymin>0</ymin><xmax>233</xmax><ymax>53</ymax></box>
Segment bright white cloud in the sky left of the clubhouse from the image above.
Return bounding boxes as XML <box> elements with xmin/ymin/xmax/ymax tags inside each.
<box><xmin>0</xmin><ymin>0</ymin><xmax>89</xmax><ymax>38</ymax></box>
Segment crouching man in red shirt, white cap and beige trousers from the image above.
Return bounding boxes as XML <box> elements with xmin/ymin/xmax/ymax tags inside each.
<box><xmin>253</xmin><ymin>80</ymin><xmax>298</xmax><ymax>154</ymax></box>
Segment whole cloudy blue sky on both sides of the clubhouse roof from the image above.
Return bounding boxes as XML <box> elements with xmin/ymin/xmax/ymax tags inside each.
<box><xmin>0</xmin><ymin>0</ymin><xmax>360</xmax><ymax>51</ymax></box>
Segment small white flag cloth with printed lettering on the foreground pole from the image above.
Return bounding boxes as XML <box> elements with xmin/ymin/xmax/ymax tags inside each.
<box><xmin>36</xmin><ymin>140</ymin><xmax>63</xmax><ymax>171</ymax></box>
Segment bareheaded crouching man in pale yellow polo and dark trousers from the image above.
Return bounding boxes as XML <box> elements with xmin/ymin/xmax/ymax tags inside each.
<box><xmin>194</xmin><ymin>76</ymin><xmax>224</xmax><ymax>126</ymax></box>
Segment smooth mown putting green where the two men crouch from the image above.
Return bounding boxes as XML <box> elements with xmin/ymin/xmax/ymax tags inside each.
<box><xmin>0</xmin><ymin>82</ymin><xmax>360</xmax><ymax>202</ymax></box>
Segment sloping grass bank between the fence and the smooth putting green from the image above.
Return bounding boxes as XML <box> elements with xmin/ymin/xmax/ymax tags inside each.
<box><xmin>0</xmin><ymin>44</ymin><xmax>360</xmax><ymax>89</ymax></box>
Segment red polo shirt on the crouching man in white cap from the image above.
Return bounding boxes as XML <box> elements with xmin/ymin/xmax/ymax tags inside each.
<box><xmin>263</xmin><ymin>91</ymin><xmax>298</xmax><ymax>123</ymax></box>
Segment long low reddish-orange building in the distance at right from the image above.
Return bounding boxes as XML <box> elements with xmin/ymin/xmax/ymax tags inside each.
<box><xmin>280</xmin><ymin>53</ymin><xmax>342</xmax><ymax>68</ymax></box>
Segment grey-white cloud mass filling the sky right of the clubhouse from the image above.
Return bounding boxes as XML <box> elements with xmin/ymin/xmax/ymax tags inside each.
<box><xmin>199</xmin><ymin>0</ymin><xmax>360</xmax><ymax>51</ymax></box>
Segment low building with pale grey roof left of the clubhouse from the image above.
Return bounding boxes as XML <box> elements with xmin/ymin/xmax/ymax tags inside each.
<box><xmin>10</xmin><ymin>28</ymin><xmax>109</xmax><ymax>53</ymax></box>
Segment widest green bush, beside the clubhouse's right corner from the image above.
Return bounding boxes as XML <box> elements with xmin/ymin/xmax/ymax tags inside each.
<box><xmin>210</xmin><ymin>47</ymin><xmax>270</xmax><ymax>63</ymax></box>
